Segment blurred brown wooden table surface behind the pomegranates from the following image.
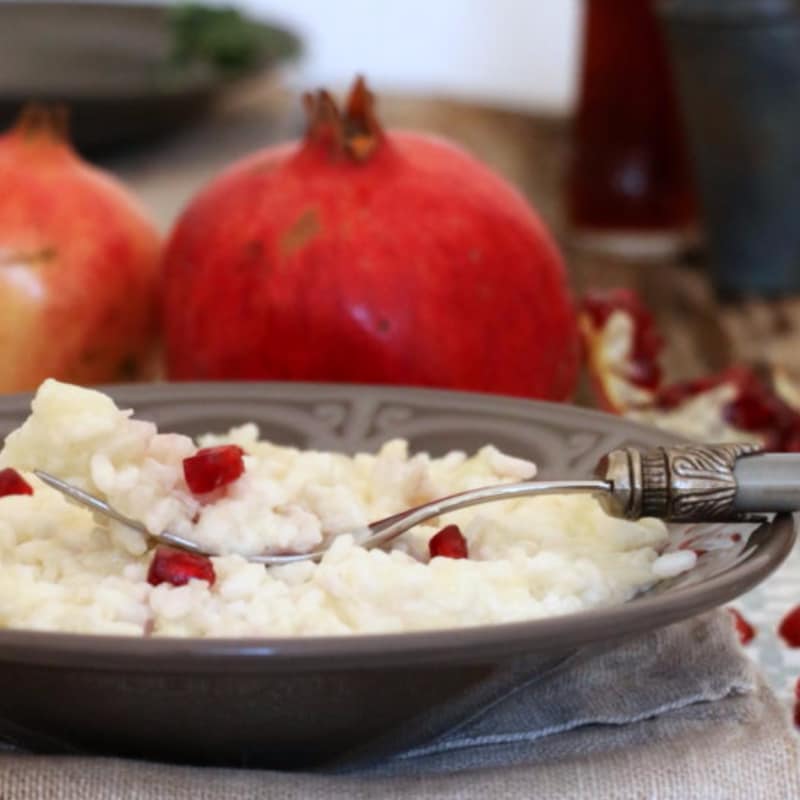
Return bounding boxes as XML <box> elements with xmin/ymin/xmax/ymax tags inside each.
<box><xmin>105</xmin><ymin>81</ymin><xmax>800</xmax><ymax>401</ymax></box>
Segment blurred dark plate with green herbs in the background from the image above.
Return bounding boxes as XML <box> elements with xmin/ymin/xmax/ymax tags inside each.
<box><xmin>0</xmin><ymin>0</ymin><xmax>299</xmax><ymax>153</ymax></box>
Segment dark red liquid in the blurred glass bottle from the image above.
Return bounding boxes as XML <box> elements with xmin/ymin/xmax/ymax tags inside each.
<box><xmin>567</xmin><ymin>0</ymin><xmax>702</xmax><ymax>253</ymax></box>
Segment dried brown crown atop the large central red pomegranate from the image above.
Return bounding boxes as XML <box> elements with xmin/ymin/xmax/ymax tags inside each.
<box><xmin>303</xmin><ymin>75</ymin><xmax>384</xmax><ymax>162</ymax></box>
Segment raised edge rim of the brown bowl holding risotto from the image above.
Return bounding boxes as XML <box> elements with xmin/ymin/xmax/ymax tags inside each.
<box><xmin>0</xmin><ymin>381</ymin><xmax>797</xmax><ymax>673</ymax></box>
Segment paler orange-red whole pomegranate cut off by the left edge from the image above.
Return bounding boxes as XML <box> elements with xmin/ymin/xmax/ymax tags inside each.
<box><xmin>0</xmin><ymin>107</ymin><xmax>160</xmax><ymax>392</ymax></box>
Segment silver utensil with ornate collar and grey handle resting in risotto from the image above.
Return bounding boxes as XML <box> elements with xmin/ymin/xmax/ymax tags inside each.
<box><xmin>29</xmin><ymin>444</ymin><xmax>800</xmax><ymax>566</ymax></box>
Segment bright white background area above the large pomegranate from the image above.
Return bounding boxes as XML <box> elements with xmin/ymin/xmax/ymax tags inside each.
<box><xmin>86</xmin><ymin>0</ymin><xmax>580</xmax><ymax>110</ymax></box>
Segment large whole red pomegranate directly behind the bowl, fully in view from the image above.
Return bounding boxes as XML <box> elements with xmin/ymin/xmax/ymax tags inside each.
<box><xmin>163</xmin><ymin>80</ymin><xmax>579</xmax><ymax>400</ymax></box>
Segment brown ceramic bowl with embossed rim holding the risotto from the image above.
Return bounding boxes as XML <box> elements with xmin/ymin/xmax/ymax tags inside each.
<box><xmin>0</xmin><ymin>383</ymin><xmax>795</xmax><ymax>767</ymax></box>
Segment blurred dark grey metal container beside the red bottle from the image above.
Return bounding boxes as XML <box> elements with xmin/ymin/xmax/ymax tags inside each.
<box><xmin>659</xmin><ymin>0</ymin><xmax>800</xmax><ymax>297</ymax></box>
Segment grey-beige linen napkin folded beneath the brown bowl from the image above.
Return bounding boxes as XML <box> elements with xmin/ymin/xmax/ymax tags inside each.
<box><xmin>0</xmin><ymin>611</ymin><xmax>800</xmax><ymax>800</ymax></box>
